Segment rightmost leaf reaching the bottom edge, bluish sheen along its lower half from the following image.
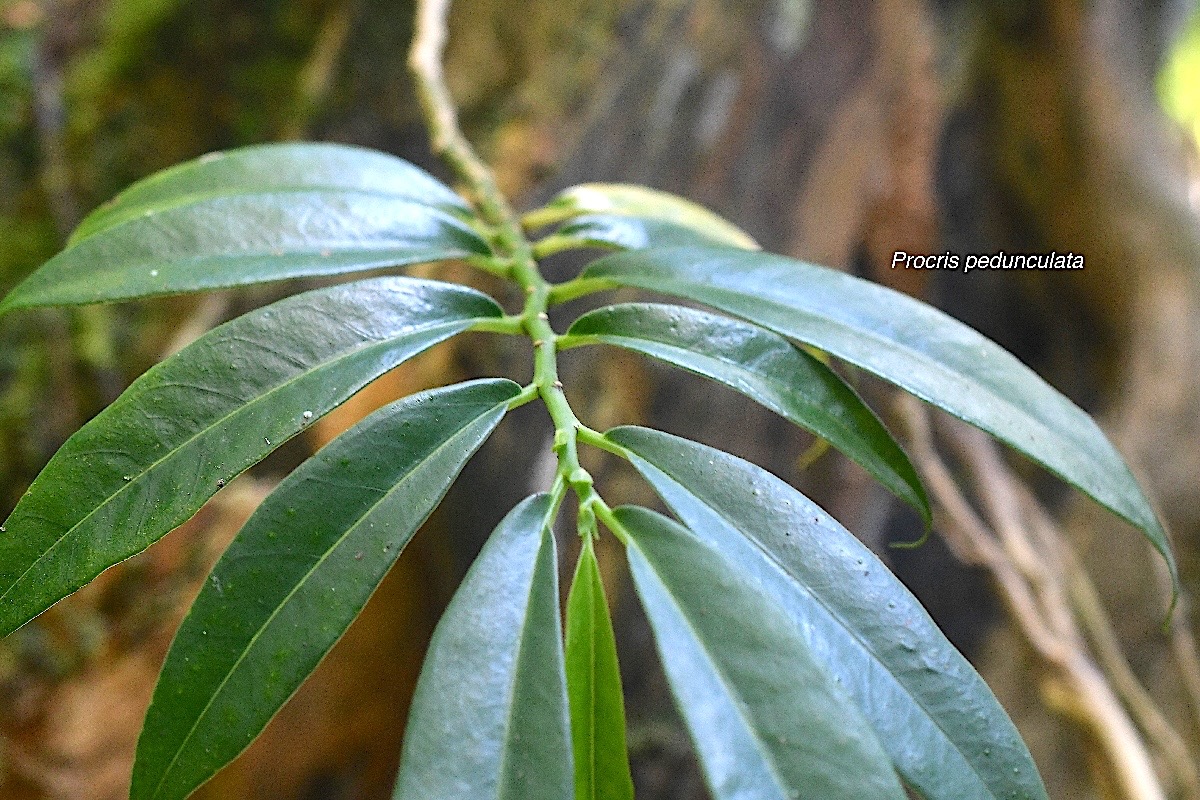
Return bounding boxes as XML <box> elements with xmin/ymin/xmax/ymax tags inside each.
<box><xmin>606</xmin><ymin>427</ymin><xmax>1046</xmax><ymax>800</ymax></box>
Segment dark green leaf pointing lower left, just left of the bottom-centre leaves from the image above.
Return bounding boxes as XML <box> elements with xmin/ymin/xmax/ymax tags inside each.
<box><xmin>130</xmin><ymin>380</ymin><xmax>521</xmax><ymax>800</ymax></box>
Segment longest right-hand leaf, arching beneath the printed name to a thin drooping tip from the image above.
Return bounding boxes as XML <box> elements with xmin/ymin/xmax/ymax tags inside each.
<box><xmin>583</xmin><ymin>247</ymin><xmax>1178</xmax><ymax>585</ymax></box>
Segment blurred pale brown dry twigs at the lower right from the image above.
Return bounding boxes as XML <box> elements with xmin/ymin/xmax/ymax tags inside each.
<box><xmin>899</xmin><ymin>396</ymin><xmax>1200</xmax><ymax>800</ymax></box>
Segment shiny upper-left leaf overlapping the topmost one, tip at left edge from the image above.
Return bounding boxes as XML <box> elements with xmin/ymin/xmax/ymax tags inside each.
<box><xmin>0</xmin><ymin>190</ymin><xmax>488</xmax><ymax>314</ymax></box>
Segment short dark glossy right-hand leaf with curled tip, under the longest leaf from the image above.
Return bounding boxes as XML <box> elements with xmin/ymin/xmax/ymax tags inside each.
<box><xmin>559</xmin><ymin>303</ymin><xmax>931</xmax><ymax>524</ymax></box>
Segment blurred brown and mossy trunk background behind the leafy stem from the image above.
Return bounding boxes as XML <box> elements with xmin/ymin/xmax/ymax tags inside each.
<box><xmin>0</xmin><ymin>0</ymin><xmax>1200</xmax><ymax>800</ymax></box>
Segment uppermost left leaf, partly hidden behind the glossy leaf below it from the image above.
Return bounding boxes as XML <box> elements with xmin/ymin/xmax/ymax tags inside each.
<box><xmin>70</xmin><ymin>142</ymin><xmax>468</xmax><ymax>245</ymax></box>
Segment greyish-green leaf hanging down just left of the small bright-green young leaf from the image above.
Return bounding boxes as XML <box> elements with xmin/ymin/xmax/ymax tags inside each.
<box><xmin>395</xmin><ymin>494</ymin><xmax>574</xmax><ymax>800</ymax></box>
